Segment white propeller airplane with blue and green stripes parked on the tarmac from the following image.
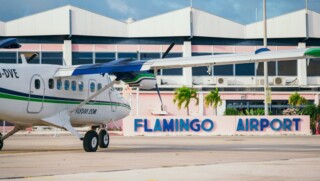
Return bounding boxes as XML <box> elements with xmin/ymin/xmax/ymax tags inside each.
<box><xmin>0</xmin><ymin>38</ymin><xmax>320</xmax><ymax>152</ymax></box>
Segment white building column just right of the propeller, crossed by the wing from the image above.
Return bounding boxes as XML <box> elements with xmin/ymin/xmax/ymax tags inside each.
<box><xmin>182</xmin><ymin>41</ymin><xmax>192</xmax><ymax>86</ymax></box>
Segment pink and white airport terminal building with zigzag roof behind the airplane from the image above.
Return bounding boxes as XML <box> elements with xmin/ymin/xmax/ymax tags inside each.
<box><xmin>0</xmin><ymin>6</ymin><xmax>320</xmax><ymax>115</ymax></box>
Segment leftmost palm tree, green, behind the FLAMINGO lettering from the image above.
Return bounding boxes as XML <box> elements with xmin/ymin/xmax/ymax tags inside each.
<box><xmin>173</xmin><ymin>86</ymin><xmax>199</xmax><ymax>116</ymax></box>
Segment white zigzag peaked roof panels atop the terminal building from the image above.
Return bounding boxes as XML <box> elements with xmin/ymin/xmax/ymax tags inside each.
<box><xmin>0</xmin><ymin>5</ymin><xmax>320</xmax><ymax>39</ymax></box>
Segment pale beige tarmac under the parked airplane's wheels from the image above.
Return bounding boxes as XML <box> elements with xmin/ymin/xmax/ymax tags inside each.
<box><xmin>0</xmin><ymin>133</ymin><xmax>320</xmax><ymax>181</ymax></box>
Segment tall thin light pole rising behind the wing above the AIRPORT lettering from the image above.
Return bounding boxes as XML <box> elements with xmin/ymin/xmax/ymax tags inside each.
<box><xmin>263</xmin><ymin>0</ymin><xmax>270</xmax><ymax>116</ymax></box>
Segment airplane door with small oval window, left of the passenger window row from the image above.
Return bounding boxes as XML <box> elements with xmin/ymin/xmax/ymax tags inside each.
<box><xmin>27</xmin><ymin>75</ymin><xmax>45</xmax><ymax>113</ymax></box>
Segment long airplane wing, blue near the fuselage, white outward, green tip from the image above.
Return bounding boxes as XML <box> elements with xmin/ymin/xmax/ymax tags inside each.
<box><xmin>55</xmin><ymin>48</ymin><xmax>320</xmax><ymax>77</ymax></box>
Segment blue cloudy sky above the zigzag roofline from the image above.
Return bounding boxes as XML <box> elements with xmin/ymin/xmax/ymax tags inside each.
<box><xmin>0</xmin><ymin>0</ymin><xmax>320</xmax><ymax>24</ymax></box>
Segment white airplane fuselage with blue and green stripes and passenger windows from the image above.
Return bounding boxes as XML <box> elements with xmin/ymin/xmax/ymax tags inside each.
<box><xmin>0</xmin><ymin>64</ymin><xmax>130</xmax><ymax>126</ymax></box>
